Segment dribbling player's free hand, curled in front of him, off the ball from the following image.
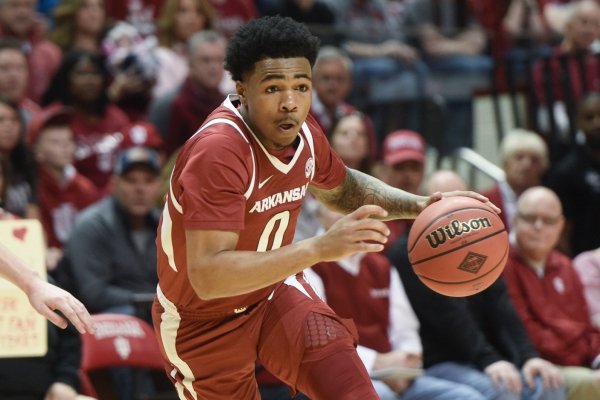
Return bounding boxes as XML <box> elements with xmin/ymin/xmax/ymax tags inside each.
<box><xmin>317</xmin><ymin>205</ymin><xmax>390</xmax><ymax>261</ymax></box>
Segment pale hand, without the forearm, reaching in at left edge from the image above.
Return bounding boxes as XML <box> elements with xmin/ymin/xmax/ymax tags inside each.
<box><xmin>27</xmin><ymin>278</ymin><xmax>96</xmax><ymax>333</ymax></box>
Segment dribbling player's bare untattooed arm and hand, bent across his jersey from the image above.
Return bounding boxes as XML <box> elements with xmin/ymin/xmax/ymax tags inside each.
<box><xmin>186</xmin><ymin>205</ymin><xmax>389</xmax><ymax>300</ymax></box>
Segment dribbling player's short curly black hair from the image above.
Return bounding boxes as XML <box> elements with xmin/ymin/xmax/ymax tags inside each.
<box><xmin>225</xmin><ymin>16</ymin><xmax>321</xmax><ymax>81</ymax></box>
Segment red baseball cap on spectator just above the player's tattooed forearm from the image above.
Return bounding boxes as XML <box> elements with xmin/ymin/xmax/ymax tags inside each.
<box><xmin>383</xmin><ymin>130</ymin><xmax>426</xmax><ymax>165</ymax></box>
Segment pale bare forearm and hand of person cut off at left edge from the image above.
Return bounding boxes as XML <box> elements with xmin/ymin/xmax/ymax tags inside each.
<box><xmin>0</xmin><ymin>241</ymin><xmax>95</xmax><ymax>333</ymax></box>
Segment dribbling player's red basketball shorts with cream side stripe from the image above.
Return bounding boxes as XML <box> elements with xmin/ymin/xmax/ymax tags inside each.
<box><xmin>153</xmin><ymin>279</ymin><xmax>377</xmax><ymax>400</ymax></box>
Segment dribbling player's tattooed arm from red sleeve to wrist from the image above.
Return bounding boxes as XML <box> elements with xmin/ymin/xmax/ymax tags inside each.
<box><xmin>311</xmin><ymin>168</ymin><xmax>427</xmax><ymax>219</ymax></box>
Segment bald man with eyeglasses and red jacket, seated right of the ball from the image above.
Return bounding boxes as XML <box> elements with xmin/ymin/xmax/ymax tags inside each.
<box><xmin>504</xmin><ymin>186</ymin><xmax>600</xmax><ymax>399</ymax></box>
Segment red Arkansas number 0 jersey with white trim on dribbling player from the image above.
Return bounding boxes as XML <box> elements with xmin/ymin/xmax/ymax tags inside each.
<box><xmin>157</xmin><ymin>96</ymin><xmax>346</xmax><ymax>317</ymax></box>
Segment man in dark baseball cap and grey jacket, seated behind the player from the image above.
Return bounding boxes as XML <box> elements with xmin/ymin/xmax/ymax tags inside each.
<box><xmin>65</xmin><ymin>147</ymin><xmax>161</xmax><ymax>321</ymax></box>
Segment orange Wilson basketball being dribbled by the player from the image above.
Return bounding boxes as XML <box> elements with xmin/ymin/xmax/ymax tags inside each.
<box><xmin>407</xmin><ymin>196</ymin><xmax>509</xmax><ymax>297</ymax></box>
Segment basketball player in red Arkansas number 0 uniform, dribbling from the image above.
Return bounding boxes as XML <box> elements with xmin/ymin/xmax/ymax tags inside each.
<box><xmin>153</xmin><ymin>17</ymin><xmax>496</xmax><ymax>400</ymax></box>
